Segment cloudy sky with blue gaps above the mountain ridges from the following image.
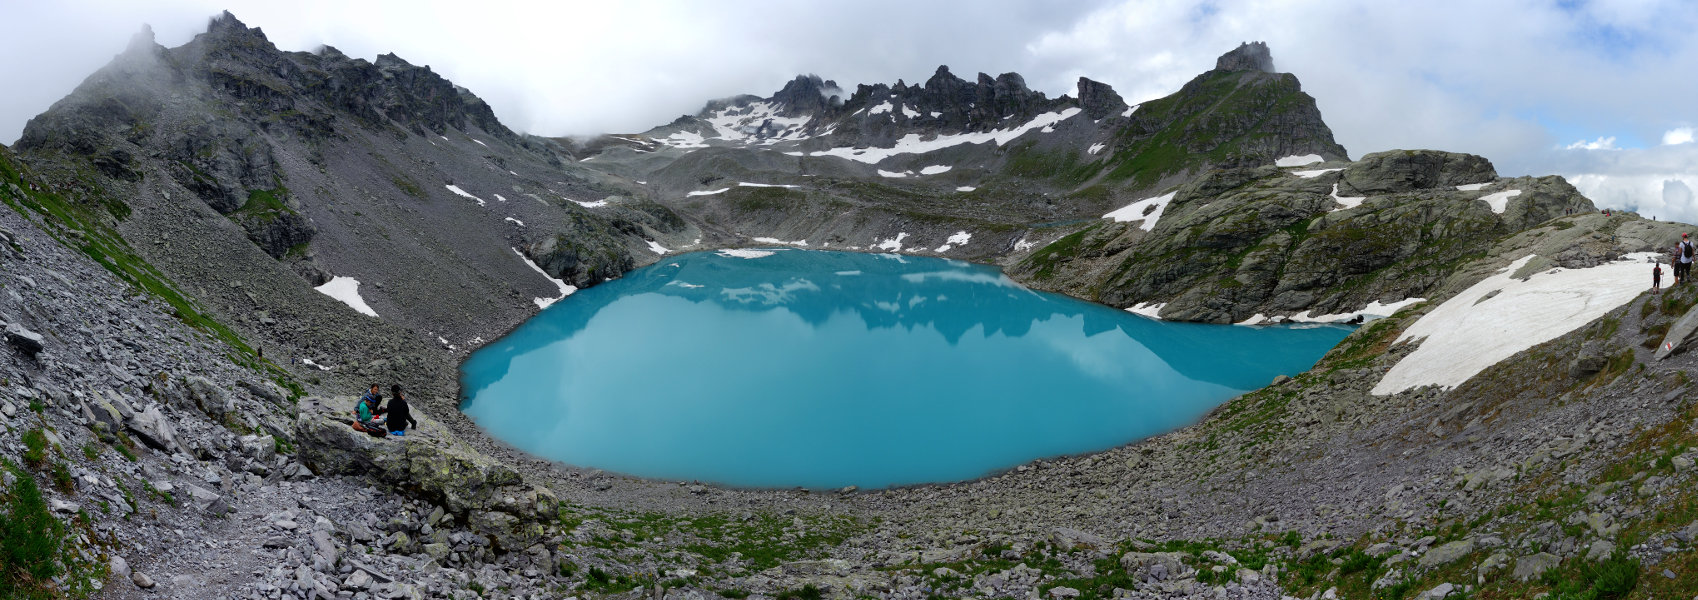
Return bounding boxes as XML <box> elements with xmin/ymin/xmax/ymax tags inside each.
<box><xmin>0</xmin><ymin>0</ymin><xmax>1698</xmax><ymax>223</ymax></box>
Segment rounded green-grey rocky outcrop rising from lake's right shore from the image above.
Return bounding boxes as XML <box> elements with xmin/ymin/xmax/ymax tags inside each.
<box><xmin>1014</xmin><ymin>151</ymin><xmax>1613</xmax><ymax>323</ymax></box>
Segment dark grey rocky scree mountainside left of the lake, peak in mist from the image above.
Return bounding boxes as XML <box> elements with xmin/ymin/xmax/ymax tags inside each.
<box><xmin>15</xmin><ymin>14</ymin><xmax>700</xmax><ymax>404</ymax></box>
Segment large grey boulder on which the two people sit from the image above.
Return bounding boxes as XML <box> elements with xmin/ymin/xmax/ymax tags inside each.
<box><xmin>295</xmin><ymin>396</ymin><xmax>522</xmax><ymax>516</ymax></box>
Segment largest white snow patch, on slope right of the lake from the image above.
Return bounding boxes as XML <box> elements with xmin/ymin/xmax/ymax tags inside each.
<box><xmin>1370</xmin><ymin>252</ymin><xmax>1657</xmax><ymax>396</ymax></box>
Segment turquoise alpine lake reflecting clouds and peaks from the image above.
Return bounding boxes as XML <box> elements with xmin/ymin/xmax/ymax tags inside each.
<box><xmin>460</xmin><ymin>248</ymin><xmax>1350</xmax><ymax>490</ymax></box>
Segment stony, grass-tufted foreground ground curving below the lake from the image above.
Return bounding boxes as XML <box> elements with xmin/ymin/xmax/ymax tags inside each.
<box><xmin>0</xmin><ymin>164</ymin><xmax>1698</xmax><ymax>598</ymax></box>
